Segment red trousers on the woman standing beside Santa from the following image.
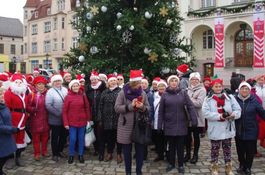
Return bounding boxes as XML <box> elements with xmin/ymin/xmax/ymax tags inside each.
<box><xmin>31</xmin><ymin>131</ymin><xmax>49</xmax><ymax>156</ymax></box>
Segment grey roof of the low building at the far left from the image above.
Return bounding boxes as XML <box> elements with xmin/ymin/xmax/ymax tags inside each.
<box><xmin>0</xmin><ymin>17</ymin><xmax>23</xmax><ymax>37</ymax></box>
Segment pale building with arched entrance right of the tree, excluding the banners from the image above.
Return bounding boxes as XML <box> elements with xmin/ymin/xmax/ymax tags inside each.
<box><xmin>178</xmin><ymin>0</ymin><xmax>265</xmax><ymax>85</ymax></box>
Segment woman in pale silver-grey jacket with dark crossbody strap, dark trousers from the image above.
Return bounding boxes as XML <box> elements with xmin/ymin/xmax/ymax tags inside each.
<box><xmin>45</xmin><ymin>74</ymin><xmax>68</xmax><ymax>162</ymax></box>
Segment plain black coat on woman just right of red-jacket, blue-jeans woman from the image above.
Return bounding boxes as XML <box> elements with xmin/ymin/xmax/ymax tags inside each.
<box><xmin>85</xmin><ymin>80</ymin><xmax>106</xmax><ymax>122</ymax></box>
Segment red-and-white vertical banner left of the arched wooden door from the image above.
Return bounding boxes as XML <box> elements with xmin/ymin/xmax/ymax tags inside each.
<box><xmin>215</xmin><ymin>18</ymin><xmax>224</xmax><ymax>67</ymax></box>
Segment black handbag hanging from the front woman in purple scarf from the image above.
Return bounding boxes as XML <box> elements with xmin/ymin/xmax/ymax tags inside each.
<box><xmin>131</xmin><ymin>110</ymin><xmax>152</xmax><ymax>145</ymax></box>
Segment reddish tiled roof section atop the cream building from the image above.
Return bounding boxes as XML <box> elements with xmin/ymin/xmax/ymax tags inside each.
<box><xmin>29</xmin><ymin>0</ymin><xmax>51</xmax><ymax>21</ymax></box>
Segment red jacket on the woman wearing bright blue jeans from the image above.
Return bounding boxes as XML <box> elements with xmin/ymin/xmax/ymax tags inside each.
<box><xmin>63</xmin><ymin>90</ymin><xmax>90</xmax><ymax>127</ymax></box>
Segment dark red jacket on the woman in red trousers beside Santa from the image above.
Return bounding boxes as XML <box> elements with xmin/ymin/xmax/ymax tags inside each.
<box><xmin>27</xmin><ymin>88</ymin><xmax>50</xmax><ymax>133</ymax></box>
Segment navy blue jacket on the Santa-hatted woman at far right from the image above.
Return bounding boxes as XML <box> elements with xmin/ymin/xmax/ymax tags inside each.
<box><xmin>236</xmin><ymin>93</ymin><xmax>265</xmax><ymax>140</ymax></box>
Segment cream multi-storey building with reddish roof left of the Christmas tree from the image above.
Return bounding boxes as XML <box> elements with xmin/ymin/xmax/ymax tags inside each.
<box><xmin>23</xmin><ymin>0</ymin><xmax>79</xmax><ymax>73</ymax></box>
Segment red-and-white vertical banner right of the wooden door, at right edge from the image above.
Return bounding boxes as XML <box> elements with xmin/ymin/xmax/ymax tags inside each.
<box><xmin>253</xmin><ymin>13</ymin><xmax>264</xmax><ymax>67</ymax></box>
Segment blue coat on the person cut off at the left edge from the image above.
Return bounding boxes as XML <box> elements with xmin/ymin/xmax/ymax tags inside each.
<box><xmin>0</xmin><ymin>103</ymin><xmax>17</xmax><ymax>158</ymax></box>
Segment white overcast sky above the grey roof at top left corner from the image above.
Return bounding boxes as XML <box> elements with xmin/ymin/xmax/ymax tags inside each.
<box><xmin>0</xmin><ymin>0</ymin><xmax>27</xmax><ymax>25</ymax></box>
